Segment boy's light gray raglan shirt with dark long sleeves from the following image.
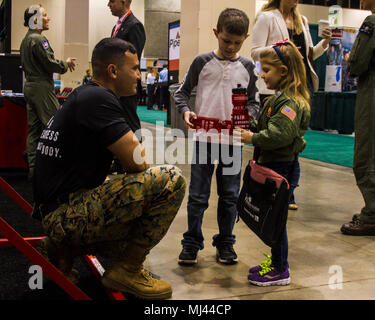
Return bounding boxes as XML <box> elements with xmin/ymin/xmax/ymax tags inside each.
<box><xmin>174</xmin><ymin>52</ymin><xmax>259</xmax><ymax>120</ymax></box>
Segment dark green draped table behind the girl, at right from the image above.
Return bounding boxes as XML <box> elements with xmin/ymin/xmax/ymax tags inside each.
<box><xmin>310</xmin><ymin>92</ymin><xmax>357</xmax><ymax>134</ymax></box>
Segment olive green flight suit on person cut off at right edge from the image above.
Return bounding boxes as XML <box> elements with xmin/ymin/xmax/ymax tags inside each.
<box><xmin>349</xmin><ymin>14</ymin><xmax>375</xmax><ymax>223</ymax></box>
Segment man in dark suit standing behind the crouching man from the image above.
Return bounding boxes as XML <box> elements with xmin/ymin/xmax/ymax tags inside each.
<box><xmin>108</xmin><ymin>0</ymin><xmax>146</xmax><ymax>140</ymax></box>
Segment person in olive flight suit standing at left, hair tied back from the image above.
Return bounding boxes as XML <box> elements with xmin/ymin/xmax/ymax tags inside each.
<box><xmin>20</xmin><ymin>5</ymin><xmax>75</xmax><ymax>180</ymax></box>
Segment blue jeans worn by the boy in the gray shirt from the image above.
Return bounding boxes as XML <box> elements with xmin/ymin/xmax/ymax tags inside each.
<box><xmin>181</xmin><ymin>142</ymin><xmax>242</xmax><ymax>250</ymax></box>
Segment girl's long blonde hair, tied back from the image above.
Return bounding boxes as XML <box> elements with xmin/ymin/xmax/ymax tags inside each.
<box><xmin>260</xmin><ymin>41</ymin><xmax>310</xmax><ymax>110</ymax></box>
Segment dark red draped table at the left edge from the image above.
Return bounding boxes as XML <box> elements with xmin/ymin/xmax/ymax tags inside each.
<box><xmin>0</xmin><ymin>97</ymin><xmax>28</xmax><ymax>169</ymax></box>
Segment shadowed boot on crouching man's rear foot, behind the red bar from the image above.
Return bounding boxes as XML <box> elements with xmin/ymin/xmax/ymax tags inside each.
<box><xmin>37</xmin><ymin>237</ymin><xmax>79</xmax><ymax>283</ymax></box>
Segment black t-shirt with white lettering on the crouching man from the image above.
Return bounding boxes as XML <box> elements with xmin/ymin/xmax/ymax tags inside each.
<box><xmin>34</xmin><ymin>82</ymin><xmax>131</xmax><ymax>205</ymax></box>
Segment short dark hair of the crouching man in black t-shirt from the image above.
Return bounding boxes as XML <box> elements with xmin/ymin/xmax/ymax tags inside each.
<box><xmin>91</xmin><ymin>38</ymin><xmax>137</xmax><ymax>76</ymax></box>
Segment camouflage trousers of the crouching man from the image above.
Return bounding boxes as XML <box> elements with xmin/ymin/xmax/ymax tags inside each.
<box><xmin>43</xmin><ymin>166</ymin><xmax>186</xmax><ymax>263</ymax></box>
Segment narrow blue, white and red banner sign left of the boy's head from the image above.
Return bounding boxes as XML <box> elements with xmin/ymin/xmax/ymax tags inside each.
<box><xmin>168</xmin><ymin>21</ymin><xmax>181</xmax><ymax>84</ymax></box>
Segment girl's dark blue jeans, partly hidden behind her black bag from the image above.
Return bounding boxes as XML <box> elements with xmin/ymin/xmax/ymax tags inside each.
<box><xmin>262</xmin><ymin>160</ymin><xmax>300</xmax><ymax>272</ymax></box>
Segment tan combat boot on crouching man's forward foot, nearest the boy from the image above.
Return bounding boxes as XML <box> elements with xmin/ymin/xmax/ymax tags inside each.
<box><xmin>102</xmin><ymin>262</ymin><xmax>172</xmax><ymax>300</ymax></box>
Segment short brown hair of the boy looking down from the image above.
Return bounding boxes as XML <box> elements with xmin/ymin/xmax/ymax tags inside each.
<box><xmin>216</xmin><ymin>8</ymin><xmax>250</xmax><ymax>36</ymax></box>
